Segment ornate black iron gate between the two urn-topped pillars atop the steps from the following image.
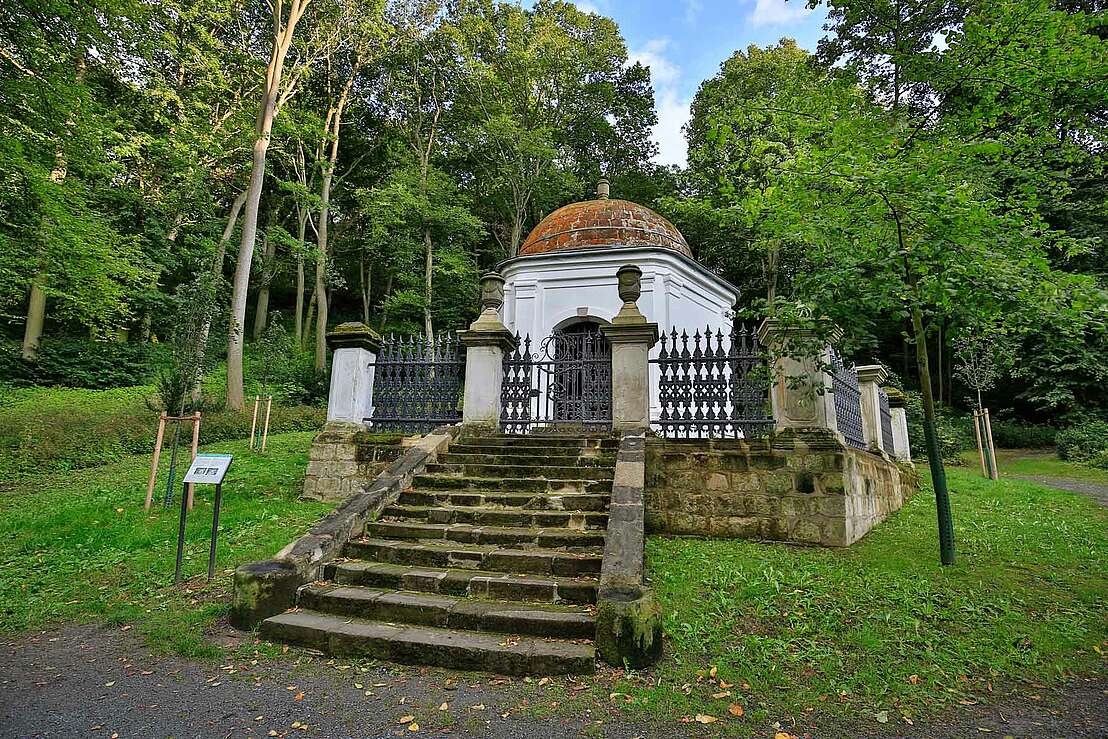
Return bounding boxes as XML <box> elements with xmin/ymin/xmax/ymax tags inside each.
<box><xmin>500</xmin><ymin>324</ymin><xmax>612</xmax><ymax>433</ymax></box>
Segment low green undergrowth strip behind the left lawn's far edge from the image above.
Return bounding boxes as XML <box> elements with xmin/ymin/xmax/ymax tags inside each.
<box><xmin>0</xmin><ymin>386</ymin><xmax>326</xmax><ymax>478</ymax></box>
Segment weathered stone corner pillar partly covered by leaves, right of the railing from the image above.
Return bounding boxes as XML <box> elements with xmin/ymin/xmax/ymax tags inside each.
<box><xmin>758</xmin><ymin>318</ymin><xmax>842</xmax><ymax>433</ymax></box>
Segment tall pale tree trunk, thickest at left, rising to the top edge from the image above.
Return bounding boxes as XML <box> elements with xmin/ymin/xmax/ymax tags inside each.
<box><xmin>227</xmin><ymin>0</ymin><xmax>310</xmax><ymax>410</ymax></box>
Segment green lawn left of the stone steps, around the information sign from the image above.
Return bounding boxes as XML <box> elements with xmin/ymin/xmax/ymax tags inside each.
<box><xmin>0</xmin><ymin>432</ymin><xmax>328</xmax><ymax>656</ymax></box>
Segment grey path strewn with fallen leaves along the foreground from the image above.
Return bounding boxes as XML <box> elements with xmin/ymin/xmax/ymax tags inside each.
<box><xmin>0</xmin><ymin>626</ymin><xmax>1108</xmax><ymax>739</ymax></box>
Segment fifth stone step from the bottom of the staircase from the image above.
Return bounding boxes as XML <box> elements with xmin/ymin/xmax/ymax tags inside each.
<box><xmin>366</xmin><ymin>521</ymin><xmax>605</xmax><ymax>548</ymax></box>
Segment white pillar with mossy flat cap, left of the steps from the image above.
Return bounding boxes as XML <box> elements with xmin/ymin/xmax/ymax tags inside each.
<box><xmin>327</xmin><ymin>321</ymin><xmax>381</xmax><ymax>428</ymax></box>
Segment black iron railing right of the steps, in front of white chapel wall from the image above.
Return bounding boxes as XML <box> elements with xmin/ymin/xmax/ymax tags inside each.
<box><xmin>650</xmin><ymin>325</ymin><xmax>773</xmax><ymax>439</ymax></box>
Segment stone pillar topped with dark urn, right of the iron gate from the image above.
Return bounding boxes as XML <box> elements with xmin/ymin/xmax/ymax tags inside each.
<box><xmin>601</xmin><ymin>265</ymin><xmax>658</xmax><ymax>431</ymax></box>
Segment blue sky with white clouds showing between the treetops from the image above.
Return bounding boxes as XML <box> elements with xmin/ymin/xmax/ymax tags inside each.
<box><xmin>562</xmin><ymin>0</ymin><xmax>825</xmax><ymax>165</ymax></box>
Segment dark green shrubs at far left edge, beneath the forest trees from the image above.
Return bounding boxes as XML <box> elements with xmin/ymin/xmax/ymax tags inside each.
<box><xmin>0</xmin><ymin>339</ymin><xmax>162</xmax><ymax>390</ymax></box>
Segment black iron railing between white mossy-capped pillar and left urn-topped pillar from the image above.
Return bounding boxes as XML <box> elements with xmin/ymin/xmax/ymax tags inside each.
<box><xmin>367</xmin><ymin>333</ymin><xmax>465</xmax><ymax>433</ymax></box>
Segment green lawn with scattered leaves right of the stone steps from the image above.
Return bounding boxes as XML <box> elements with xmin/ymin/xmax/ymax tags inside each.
<box><xmin>611</xmin><ymin>469</ymin><xmax>1108</xmax><ymax>730</ymax></box>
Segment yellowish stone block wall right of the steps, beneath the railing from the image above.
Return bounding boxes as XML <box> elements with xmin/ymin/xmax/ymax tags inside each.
<box><xmin>646</xmin><ymin>430</ymin><xmax>915</xmax><ymax>546</ymax></box>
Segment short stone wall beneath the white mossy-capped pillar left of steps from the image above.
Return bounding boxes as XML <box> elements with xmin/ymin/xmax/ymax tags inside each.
<box><xmin>304</xmin><ymin>423</ymin><xmax>406</xmax><ymax>501</ymax></box>
